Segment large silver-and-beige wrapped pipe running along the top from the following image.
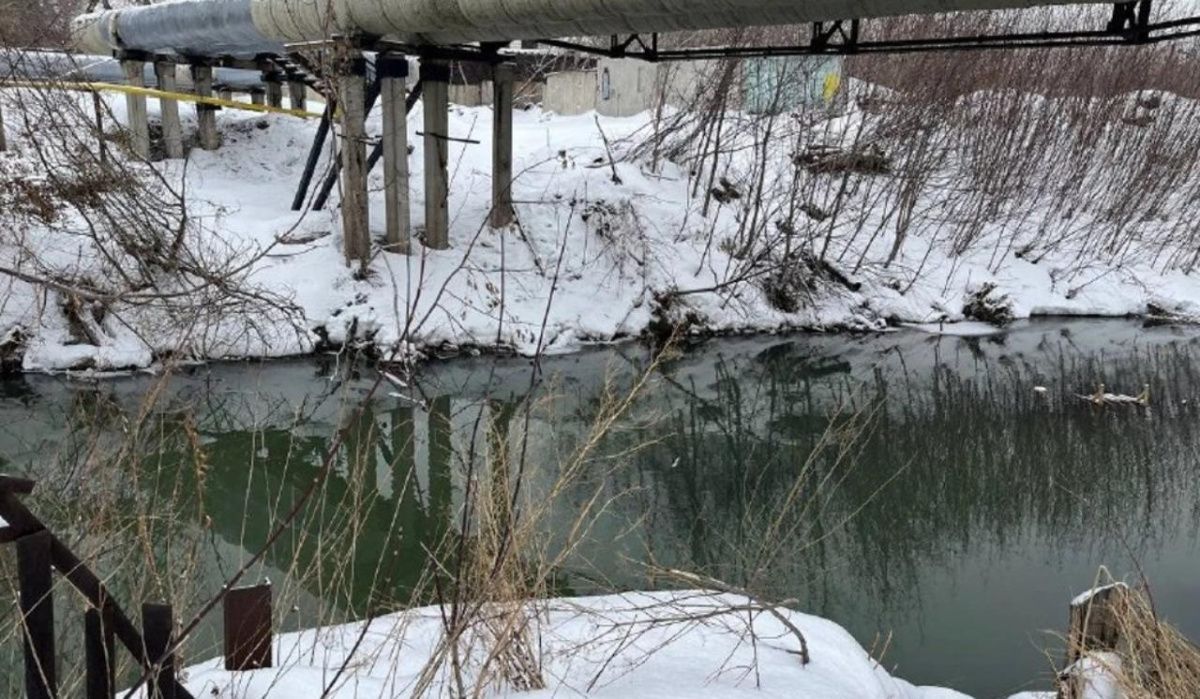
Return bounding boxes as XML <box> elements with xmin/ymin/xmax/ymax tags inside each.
<box><xmin>74</xmin><ymin>0</ymin><xmax>1098</xmax><ymax>55</ymax></box>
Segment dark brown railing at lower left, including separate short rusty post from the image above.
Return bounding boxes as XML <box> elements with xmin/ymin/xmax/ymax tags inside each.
<box><xmin>0</xmin><ymin>474</ymin><xmax>271</xmax><ymax>699</ymax></box>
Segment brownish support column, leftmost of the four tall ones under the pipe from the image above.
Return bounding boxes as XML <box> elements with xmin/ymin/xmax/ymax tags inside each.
<box><xmin>336</xmin><ymin>52</ymin><xmax>371</xmax><ymax>271</ymax></box>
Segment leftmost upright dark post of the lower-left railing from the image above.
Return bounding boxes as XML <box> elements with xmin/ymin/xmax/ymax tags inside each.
<box><xmin>17</xmin><ymin>530</ymin><xmax>58</xmax><ymax>699</ymax></box>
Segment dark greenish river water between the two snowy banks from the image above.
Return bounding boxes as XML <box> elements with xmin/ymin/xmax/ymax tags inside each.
<box><xmin>0</xmin><ymin>321</ymin><xmax>1200</xmax><ymax>697</ymax></box>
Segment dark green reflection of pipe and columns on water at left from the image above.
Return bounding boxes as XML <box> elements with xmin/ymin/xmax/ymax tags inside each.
<box><xmin>181</xmin><ymin>401</ymin><xmax>452</xmax><ymax>615</ymax></box>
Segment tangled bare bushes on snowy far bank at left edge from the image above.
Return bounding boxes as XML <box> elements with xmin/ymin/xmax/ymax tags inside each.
<box><xmin>0</xmin><ymin>49</ymin><xmax>305</xmax><ymax>369</ymax></box>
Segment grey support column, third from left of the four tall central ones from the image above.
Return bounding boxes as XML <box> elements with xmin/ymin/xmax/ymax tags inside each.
<box><xmin>421</xmin><ymin>60</ymin><xmax>450</xmax><ymax>250</ymax></box>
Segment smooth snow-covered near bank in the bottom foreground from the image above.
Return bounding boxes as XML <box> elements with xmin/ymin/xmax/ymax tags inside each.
<box><xmin>145</xmin><ymin>592</ymin><xmax>965</xmax><ymax>699</ymax></box>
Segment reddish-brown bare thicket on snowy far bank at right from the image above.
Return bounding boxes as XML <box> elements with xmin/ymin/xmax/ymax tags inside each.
<box><xmin>631</xmin><ymin>7</ymin><xmax>1200</xmax><ymax>310</ymax></box>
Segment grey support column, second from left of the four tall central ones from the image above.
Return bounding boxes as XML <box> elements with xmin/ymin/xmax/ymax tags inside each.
<box><xmin>376</xmin><ymin>54</ymin><xmax>412</xmax><ymax>255</ymax></box>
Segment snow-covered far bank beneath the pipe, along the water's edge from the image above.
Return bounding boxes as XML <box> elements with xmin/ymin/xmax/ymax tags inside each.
<box><xmin>0</xmin><ymin>83</ymin><xmax>1200</xmax><ymax>370</ymax></box>
